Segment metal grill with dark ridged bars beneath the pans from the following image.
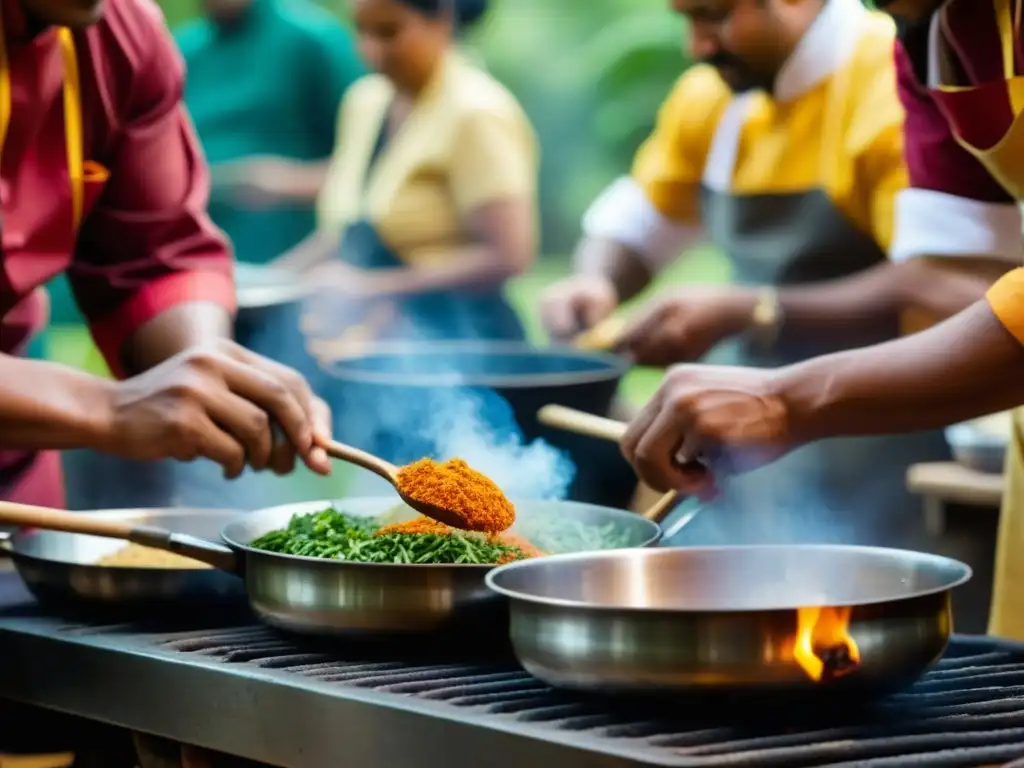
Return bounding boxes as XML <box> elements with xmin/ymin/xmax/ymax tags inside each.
<box><xmin>0</xmin><ymin>581</ymin><xmax>1024</xmax><ymax>768</ymax></box>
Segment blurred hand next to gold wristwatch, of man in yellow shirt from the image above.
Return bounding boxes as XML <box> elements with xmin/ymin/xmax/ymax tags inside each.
<box><xmin>616</xmin><ymin>286</ymin><xmax>757</xmax><ymax>366</ymax></box>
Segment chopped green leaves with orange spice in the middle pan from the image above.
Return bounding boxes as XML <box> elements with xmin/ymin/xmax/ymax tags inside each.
<box><xmin>251</xmin><ymin>508</ymin><xmax>543</xmax><ymax>565</ymax></box>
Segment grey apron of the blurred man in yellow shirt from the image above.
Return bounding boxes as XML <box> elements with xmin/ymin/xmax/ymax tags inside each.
<box><xmin>669</xmin><ymin>141</ymin><xmax>948</xmax><ymax>548</ymax></box>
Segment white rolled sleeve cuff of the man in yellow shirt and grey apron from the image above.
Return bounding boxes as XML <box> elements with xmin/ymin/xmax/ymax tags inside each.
<box><xmin>583</xmin><ymin>176</ymin><xmax>700</xmax><ymax>273</ymax></box>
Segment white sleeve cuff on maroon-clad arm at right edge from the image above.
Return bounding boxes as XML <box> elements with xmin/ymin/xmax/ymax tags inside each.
<box><xmin>889</xmin><ymin>188</ymin><xmax>1024</xmax><ymax>264</ymax></box>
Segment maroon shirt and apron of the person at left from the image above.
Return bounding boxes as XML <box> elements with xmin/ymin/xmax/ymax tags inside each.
<box><xmin>0</xmin><ymin>0</ymin><xmax>234</xmax><ymax>499</ymax></box>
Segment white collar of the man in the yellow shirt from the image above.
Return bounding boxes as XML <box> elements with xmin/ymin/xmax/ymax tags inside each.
<box><xmin>772</xmin><ymin>0</ymin><xmax>870</xmax><ymax>101</ymax></box>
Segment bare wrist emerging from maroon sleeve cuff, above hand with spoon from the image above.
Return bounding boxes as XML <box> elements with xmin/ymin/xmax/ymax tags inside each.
<box><xmin>124</xmin><ymin>302</ymin><xmax>231</xmax><ymax>375</ymax></box>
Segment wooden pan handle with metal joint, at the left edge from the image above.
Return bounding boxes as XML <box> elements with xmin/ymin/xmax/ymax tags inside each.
<box><xmin>0</xmin><ymin>502</ymin><xmax>241</xmax><ymax>573</ymax></box>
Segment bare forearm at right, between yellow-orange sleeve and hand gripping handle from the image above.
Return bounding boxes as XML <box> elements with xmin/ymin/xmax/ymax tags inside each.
<box><xmin>775</xmin><ymin>300</ymin><xmax>1024</xmax><ymax>441</ymax></box>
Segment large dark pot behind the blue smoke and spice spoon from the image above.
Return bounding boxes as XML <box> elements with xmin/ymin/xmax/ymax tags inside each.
<box><xmin>328</xmin><ymin>341</ymin><xmax>636</xmax><ymax>508</ymax></box>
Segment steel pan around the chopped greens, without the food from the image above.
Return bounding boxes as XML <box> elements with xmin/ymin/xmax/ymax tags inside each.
<box><xmin>221</xmin><ymin>497</ymin><xmax>660</xmax><ymax>635</ymax></box>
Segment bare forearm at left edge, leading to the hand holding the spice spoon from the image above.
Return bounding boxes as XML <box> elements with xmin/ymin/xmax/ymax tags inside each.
<box><xmin>0</xmin><ymin>354</ymin><xmax>114</xmax><ymax>451</ymax></box>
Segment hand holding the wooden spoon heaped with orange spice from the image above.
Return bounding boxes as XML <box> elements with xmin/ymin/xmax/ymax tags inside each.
<box><xmin>96</xmin><ymin>340</ymin><xmax>331</xmax><ymax>478</ymax></box>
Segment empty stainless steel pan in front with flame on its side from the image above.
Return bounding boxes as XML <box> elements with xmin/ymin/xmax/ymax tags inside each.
<box><xmin>486</xmin><ymin>545</ymin><xmax>971</xmax><ymax>693</ymax></box>
